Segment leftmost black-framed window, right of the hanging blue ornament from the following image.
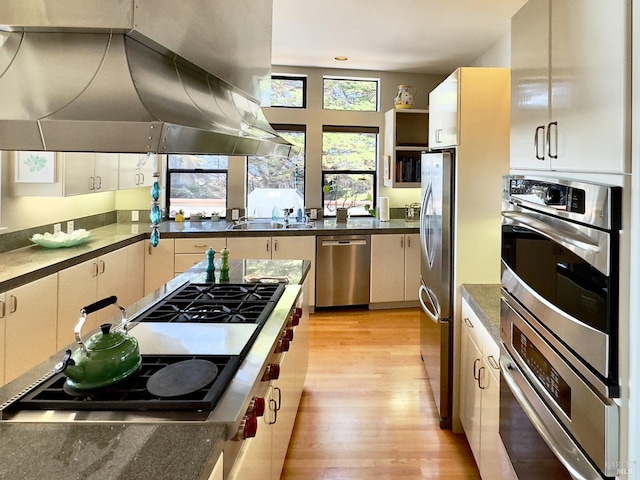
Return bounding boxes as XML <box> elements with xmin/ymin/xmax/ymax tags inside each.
<box><xmin>167</xmin><ymin>155</ymin><xmax>229</xmax><ymax>218</ymax></box>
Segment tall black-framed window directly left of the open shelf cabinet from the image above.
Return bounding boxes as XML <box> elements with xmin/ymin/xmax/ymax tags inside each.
<box><xmin>322</xmin><ymin>126</ymin><xmax>378</xmax><ymax>216</ymax></box>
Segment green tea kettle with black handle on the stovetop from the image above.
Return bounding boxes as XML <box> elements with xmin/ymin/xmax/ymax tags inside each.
<box><xmin>54</xmin><ymin>295</ymin><xmax>142</xmax><ymax>390</ymax></box>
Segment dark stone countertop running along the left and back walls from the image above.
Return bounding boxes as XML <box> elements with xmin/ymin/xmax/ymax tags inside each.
<box><xmin>0</xmin><ymin>218</ymin><xmax>420</xmax><ymax>292</ymax></box>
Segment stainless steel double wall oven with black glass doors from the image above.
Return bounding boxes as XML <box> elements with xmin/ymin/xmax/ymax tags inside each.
<box><xmin>499</xmin><ymin>176</ymin><xmax>622</xmax><ymax>480</ymax></box>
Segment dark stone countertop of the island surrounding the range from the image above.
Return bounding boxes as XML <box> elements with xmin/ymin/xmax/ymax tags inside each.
<box><xmin>0</xmin><ymin>260</ymin><xmax>309</xmax><ymax>480</ymax></box>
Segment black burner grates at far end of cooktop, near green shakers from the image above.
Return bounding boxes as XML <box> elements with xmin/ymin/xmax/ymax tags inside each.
<box><xmin>133</xmin><ymin>283</ymin><xmax>285</xmax><ymax>324</ymax></box>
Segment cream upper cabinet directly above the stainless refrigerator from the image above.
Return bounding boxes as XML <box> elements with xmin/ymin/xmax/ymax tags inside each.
<box><xmin>429</xmin><ymin>70</ymin><xmax>460</xmax><ymax>148</ymax></box>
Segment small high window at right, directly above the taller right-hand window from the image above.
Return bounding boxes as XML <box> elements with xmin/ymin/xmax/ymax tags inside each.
<box><xmin>322</xmin><ymin>77</ymin><xmax>379</xmax><ymax>112</ymax></box>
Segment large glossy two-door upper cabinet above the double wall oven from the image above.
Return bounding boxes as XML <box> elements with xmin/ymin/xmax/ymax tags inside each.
<box><xmin>510</xmin><ymin>0</ymin><xmax>631</xmax><ymax>173</ymax></box>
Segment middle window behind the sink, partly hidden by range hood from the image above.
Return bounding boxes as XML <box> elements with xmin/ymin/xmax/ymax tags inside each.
<box><xmin>246</xmin><ymin>125</ymin><xmax>306</xmax><ymax>218</ymax></box>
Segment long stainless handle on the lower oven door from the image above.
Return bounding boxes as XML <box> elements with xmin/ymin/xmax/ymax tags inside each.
<box><xmin>500</xmin><ymin>350</ymin><xmax>602</xmax><ymax>480</ymax></box>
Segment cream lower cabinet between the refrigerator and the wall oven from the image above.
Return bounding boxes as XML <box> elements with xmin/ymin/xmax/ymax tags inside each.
<box><xmin>460</xmin><ymin>299</ymin><xmax>501</xmax><ymax>480</ymax></box>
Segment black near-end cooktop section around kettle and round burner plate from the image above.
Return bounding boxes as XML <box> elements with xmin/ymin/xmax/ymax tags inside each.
<box><xmin>7</xmin><ymin>355</ymin><xmax>241</xmax><ymax>411</ymax></box>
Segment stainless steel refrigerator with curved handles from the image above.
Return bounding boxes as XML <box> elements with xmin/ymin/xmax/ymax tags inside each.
<box><xmin>419</xmin><ymin>150</ymin><xmax>455</xmax><ymax>428</ymax></box>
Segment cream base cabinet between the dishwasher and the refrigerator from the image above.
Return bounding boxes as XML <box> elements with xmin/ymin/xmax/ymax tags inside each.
<box><xmin>370</xmin><ymin>233</ymin><xmax>420</xmax><ymax>303</ymax></box>
